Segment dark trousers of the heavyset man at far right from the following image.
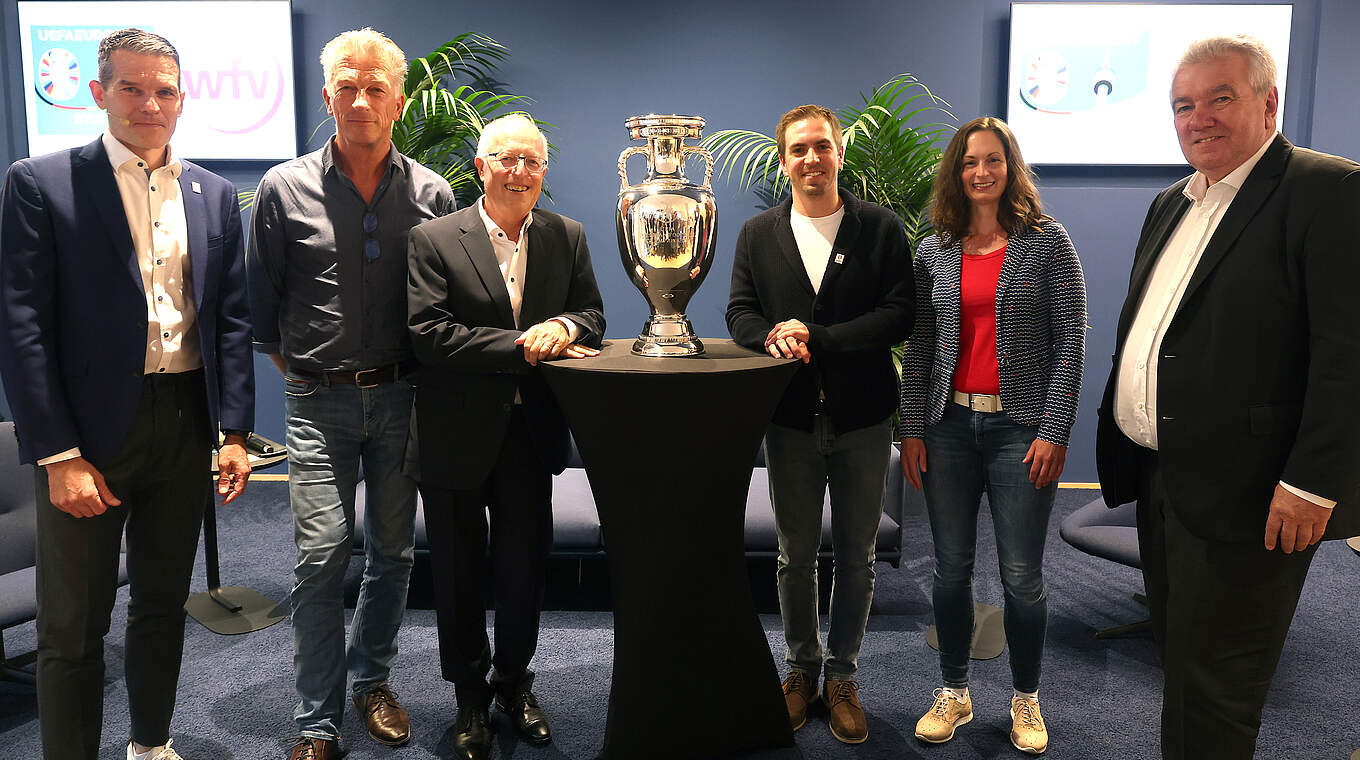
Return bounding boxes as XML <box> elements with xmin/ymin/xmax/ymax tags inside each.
<box><xmin>1138</xmin><ymin>451</ymin><xmax>1318</xmax><ymax>760</ymax></box>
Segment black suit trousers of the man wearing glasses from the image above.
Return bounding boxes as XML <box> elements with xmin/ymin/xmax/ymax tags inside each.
<box><xmin>420</xmin><ymin>405</ymin><xmax>552</xmax><ymax>706</ymax></box>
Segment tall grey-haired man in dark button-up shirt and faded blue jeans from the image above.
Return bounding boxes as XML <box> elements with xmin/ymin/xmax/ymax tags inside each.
<box><xmin>246</xmin><ymin>29</ymin><xmax>454</xmax><ymax>760</ymax></box>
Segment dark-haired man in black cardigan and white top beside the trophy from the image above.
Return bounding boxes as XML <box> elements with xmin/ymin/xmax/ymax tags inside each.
<box><xmin>728</xmin><ymin>106</ymin><xmax>914</xmax><ymax>744</ymax></box>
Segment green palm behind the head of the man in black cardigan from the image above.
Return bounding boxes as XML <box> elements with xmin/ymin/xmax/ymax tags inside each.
<box><xmin>703</xmin><ymin>73</ymin><xmax>957</xmax><ymax>245</ymax></box>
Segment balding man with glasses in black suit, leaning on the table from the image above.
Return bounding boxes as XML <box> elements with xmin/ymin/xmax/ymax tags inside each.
<box><xmin>407</xmin><ymin>114</ymin><xmax>604</xmax><ymax>760</ymax></box>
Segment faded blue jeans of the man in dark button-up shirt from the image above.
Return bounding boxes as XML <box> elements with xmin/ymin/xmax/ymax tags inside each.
<box><xmin>284</xmin><ymin>378</ymin><xmax>416</xmax><ymax>738</ymax></box>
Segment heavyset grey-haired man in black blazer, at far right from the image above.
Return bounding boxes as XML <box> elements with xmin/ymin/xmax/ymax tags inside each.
<box><xmin>1096</xmin><ymin>35</ymin><xmax>1360</xmax><ymax>759</ymax></box>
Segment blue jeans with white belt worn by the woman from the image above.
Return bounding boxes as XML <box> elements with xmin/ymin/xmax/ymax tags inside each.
<box><xmin>925</xmin><ymin>404</ymin><xmax>1058</xmax><ymax>692</ymax></box>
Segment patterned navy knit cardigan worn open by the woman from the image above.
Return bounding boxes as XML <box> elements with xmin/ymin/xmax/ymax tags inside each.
<box><xmin>902</xmin><ymin>220</ymin><xmax>1087</xmax><ymax>446</ymax></box>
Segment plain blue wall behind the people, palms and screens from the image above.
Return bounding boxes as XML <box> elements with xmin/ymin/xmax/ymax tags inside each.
<box><xmin>0</xmin><ymin>0</ymin><xmax>1360</xmax><ymax>481</ymax></box>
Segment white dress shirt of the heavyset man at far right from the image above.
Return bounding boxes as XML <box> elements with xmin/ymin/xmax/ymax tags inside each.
<box><xmin>1114</xmin><ymin>133</ymin><xmax>1336</xmax><ymax>507</ymax></box>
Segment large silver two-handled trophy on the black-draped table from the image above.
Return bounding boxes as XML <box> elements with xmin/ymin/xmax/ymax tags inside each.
<box><xmin>615</xmin><ymin>113</ymin><xmax>718</xmax><ymax>356</ymax></box>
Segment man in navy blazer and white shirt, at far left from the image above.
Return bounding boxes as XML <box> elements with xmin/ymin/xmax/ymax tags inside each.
<box><xmin>0</xmin><ymin>29</ymin><xmax>254</xmax><ymax>760</ymax></box>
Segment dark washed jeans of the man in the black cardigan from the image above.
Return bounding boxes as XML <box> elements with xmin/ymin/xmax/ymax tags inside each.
<box><xmin>766</xmin><ymin>415</ymin><xmax>892</xmax><ymax>680</ymax></box>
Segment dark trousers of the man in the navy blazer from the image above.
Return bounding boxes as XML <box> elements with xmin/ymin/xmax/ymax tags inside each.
<box><xmin>37</xmin><ymin>370</ymin><xmax>211</xmax><ymax>760</ymax></box>
